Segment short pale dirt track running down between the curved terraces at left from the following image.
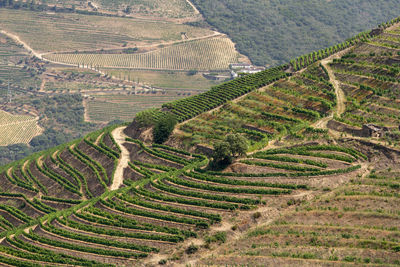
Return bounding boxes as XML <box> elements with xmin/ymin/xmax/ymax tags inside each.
<box><xmin>110</xmin><ymin>126</ymin><xmax>130</xmax><ymax>190</ymax></box>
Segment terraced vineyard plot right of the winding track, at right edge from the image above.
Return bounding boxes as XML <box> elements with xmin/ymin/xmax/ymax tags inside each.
<box><xmin>329</xmin><ymin>22</ymin><xmax>400</xmax><ymax>145</ymax></box>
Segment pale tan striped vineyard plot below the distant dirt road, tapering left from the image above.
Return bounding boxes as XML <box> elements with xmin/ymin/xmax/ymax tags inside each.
<box><xmin>46</xmin><ymin>37</ymin><xmax>238</xmax><ymax>70</ymax></box>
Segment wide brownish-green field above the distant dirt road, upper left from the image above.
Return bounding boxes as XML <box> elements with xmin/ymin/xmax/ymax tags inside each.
<box><xmin>0</xmin><ymin>8</ymin><xmax>214</xmax><ymax>52</ymax></box>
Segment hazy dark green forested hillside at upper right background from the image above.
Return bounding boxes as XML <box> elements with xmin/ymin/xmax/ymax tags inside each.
<box><xmin>192</xmin><ymin>0</ymin><xmax>400</xmax><ymax>65</ymax></box>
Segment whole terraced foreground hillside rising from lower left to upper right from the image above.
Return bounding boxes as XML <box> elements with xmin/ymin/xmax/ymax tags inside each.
<box><xmin>0</xmin><ymin>19</ymin><xmax>400</xmax><ymax>266</ymax></box>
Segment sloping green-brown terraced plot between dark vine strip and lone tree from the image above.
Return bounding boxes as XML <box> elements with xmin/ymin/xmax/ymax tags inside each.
<box><xmin>170</xmin><ymin>62</ymin><xmax>336</xmax><ymax>150</ymax></box>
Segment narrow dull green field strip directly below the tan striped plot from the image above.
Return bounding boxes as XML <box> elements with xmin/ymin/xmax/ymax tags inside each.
<box><xmin>101</xmin><ymin>69</ymin><xmax>219</xmax><ymax>91</ymax></box>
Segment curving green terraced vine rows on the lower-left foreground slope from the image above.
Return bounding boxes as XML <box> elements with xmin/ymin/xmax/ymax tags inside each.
<box><xmin>0</xmin><ymin>120</ymin><xmax>365</xmax><ymax>265</ymax></box>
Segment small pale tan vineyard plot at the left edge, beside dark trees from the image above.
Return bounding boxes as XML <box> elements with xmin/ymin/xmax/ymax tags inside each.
<box><xmin>0</xmin><ymin>110</ymin><xmax>42</xmax><ymax>146</ymax></box>
